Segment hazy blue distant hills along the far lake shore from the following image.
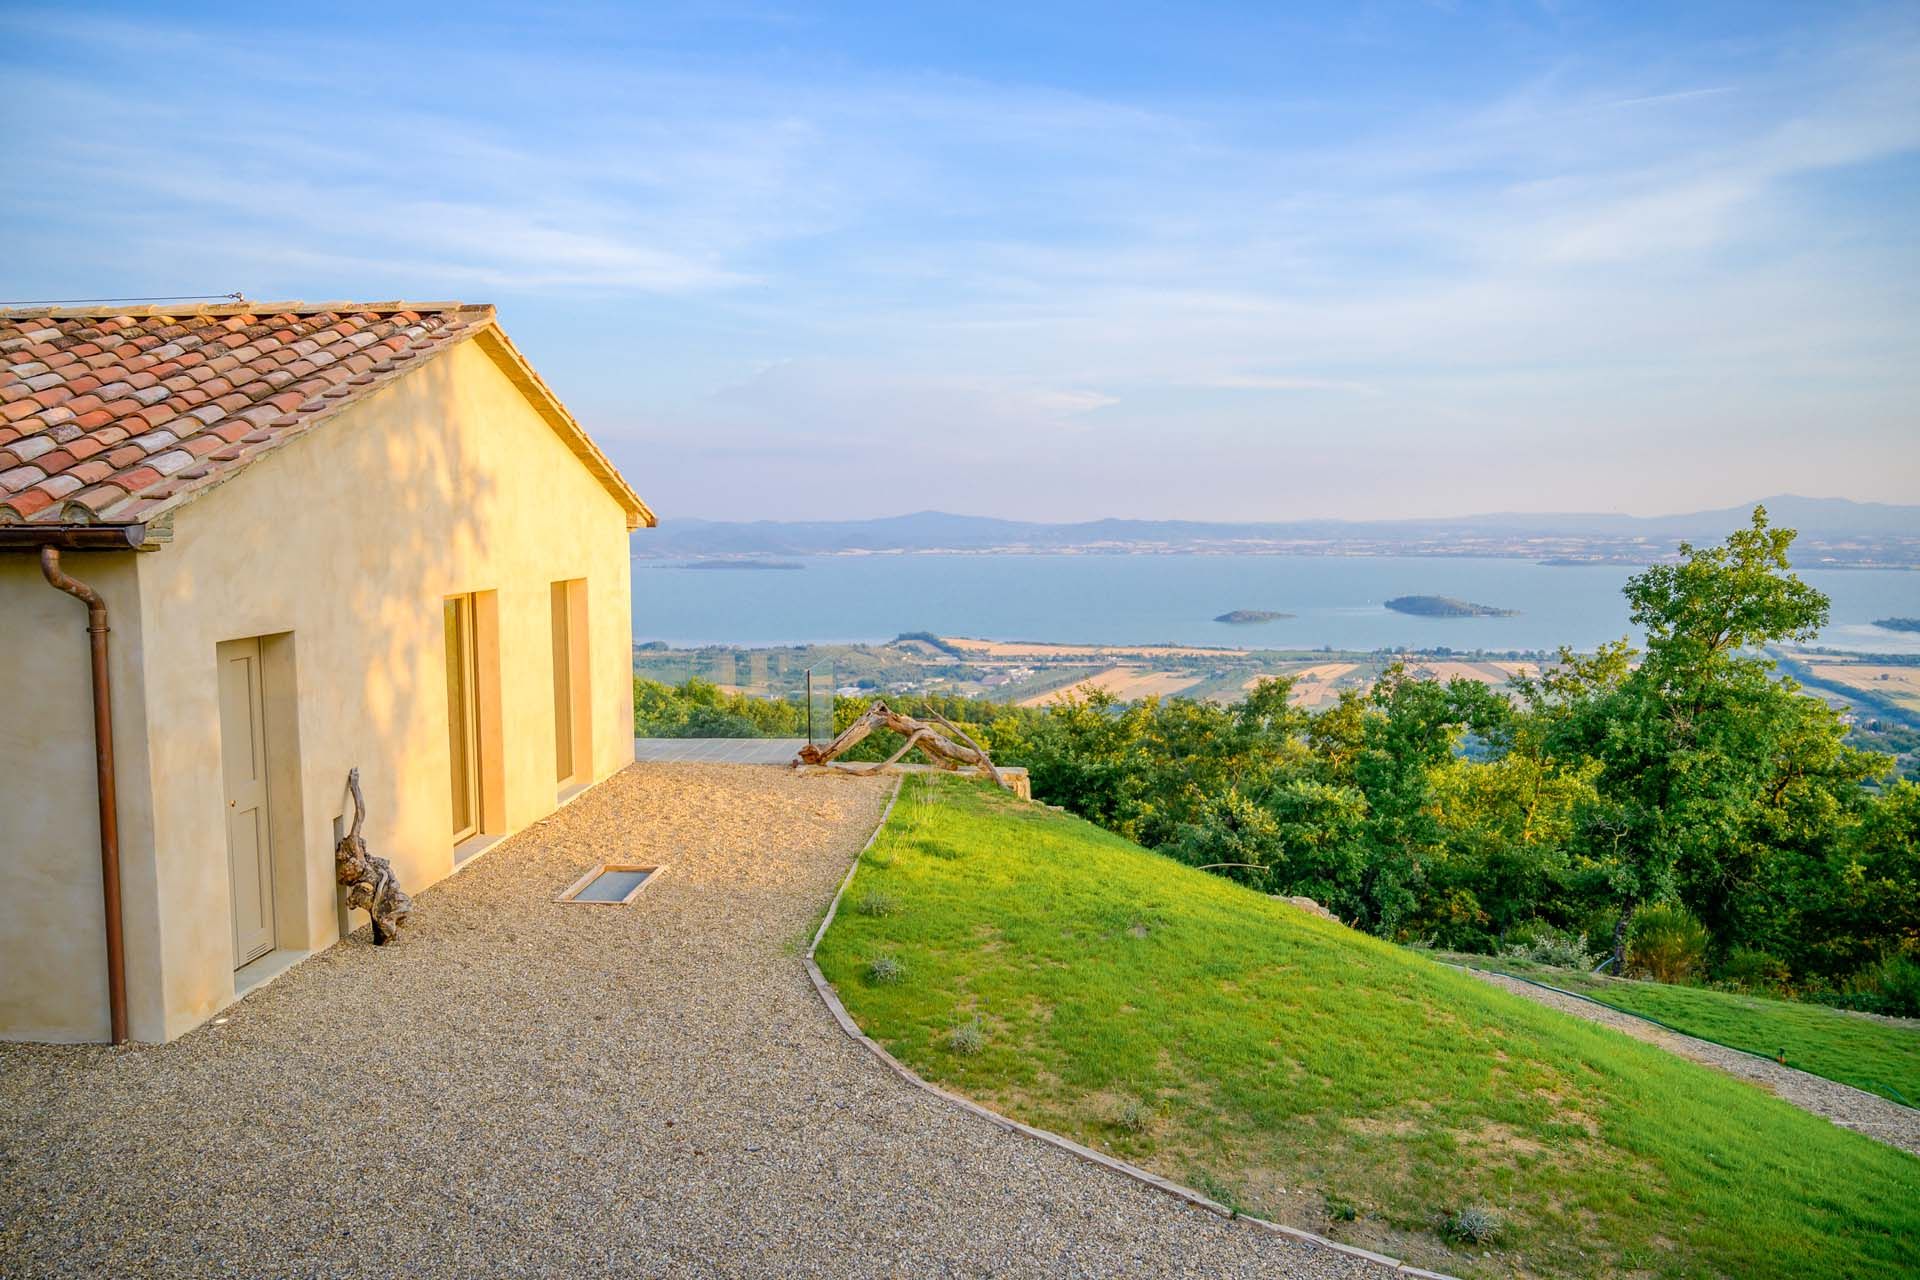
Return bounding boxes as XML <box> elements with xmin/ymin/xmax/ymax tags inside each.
<box><xmin>634</xmin><ymin>495</ymin><xmax>1920</xmax><ymax>564</ymax></box>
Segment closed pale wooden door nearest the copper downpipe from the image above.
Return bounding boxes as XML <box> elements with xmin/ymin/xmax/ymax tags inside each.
<box><xmin>219</xmin><ymin>639</ymin><xmax>273</xmax><ymax>969</ymax></box>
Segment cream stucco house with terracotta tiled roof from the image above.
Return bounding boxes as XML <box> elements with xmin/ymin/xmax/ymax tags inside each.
<box><xmin>0</xmin><ymin>301</ymin><xmax>653</xmax><ymax>1040</ymax></box>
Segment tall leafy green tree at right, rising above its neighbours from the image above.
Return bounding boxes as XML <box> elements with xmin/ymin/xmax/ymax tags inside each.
<box><xmin>1544</xmin><ymin>507</ymin><xmax>1876</xmax><ymax>963</ymax></box>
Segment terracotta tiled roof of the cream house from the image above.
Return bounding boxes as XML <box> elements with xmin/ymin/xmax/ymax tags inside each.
<box><xmin>0</xmin><ymin>301</ymin><xmax>653</xmax><ymax>526</ymax></box>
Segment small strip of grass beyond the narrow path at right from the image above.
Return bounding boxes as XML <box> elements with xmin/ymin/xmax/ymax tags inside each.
<box><xmin>1450</xmin><ymin>956</ymin><xmax>1920</xmax><ymax>1105</ymax></box>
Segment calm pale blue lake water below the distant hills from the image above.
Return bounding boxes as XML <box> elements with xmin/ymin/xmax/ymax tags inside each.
<box><xmin>634</xmin><ymin>555</ymin><xmax>1920</xmax><ymax>652</ymax></box>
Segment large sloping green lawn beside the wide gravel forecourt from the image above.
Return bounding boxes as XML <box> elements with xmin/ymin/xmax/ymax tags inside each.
<box><xmin>818</xmin><ymin>777</ymin><xmax>1920</xmax><ymax>1276</ymax></box>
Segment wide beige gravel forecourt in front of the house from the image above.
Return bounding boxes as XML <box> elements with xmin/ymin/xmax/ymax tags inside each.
<box><xmin>0</xmin><ymin>766</ymin><xmax>1384</xmax><ymax>1278</ymax></box>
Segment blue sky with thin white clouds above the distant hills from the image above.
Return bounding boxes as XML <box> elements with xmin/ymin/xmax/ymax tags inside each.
<box><xmin>0</xmin><ymin>0</ymin><xmax>1920</xmax><ymax>518</ymax></box>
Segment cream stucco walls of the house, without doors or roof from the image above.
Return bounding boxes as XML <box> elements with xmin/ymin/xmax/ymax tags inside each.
<box><xmin>0</xmin><ymin>338</ymin><xmax>634</xmax><ymax>1040</ymax></box>
